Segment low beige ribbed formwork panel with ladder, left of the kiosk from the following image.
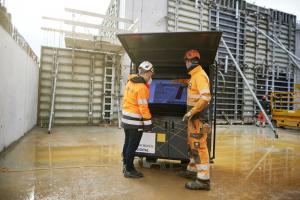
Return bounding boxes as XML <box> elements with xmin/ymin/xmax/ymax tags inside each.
<box><xmin>38</xmin><ymin>47</ymin><xmax>121</xmax><ymax>126</ymax></box>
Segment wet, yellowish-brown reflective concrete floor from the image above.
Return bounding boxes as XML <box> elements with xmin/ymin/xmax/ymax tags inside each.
<box><xmin>0</xmin><ymin>126</ymin><xmax>300</xmax><ymax>200</ymax></box>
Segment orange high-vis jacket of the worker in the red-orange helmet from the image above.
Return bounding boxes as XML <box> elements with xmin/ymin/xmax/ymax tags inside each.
<box><xmin>187</xmin><ymin>65</ymin><xmax>211</xmax><ymax>115</ymax></box>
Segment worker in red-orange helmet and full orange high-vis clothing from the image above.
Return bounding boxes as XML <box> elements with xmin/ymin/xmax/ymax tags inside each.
<box><xmin>181</xmin><ymin>49</ymin><xmax>211</xmax><ymax>190</ymax></box>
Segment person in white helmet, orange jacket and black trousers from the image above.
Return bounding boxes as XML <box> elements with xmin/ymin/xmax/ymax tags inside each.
<box><xmin>122</xmin><ymin>61</ymin><xmax>154</xmax><ymax>178</ymax></box>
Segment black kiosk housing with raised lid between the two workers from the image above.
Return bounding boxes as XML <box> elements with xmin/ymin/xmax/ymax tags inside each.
<box><xmin>117</xmin><ymin>32</ymin><xmax>222</xmax><ymax>161</ymax></box>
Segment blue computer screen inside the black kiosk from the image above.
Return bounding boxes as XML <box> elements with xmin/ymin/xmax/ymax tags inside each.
<box><xmin>149</xmin><ymin>80</ymin><xmax>187</xmax><ymax>104</ymax></box>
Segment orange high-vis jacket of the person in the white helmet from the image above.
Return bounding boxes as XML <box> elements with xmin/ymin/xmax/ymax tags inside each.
<box><xmin>122</xmin><ymin>75</ymin><xmax>152</xmax><ymax>129</ymax></box>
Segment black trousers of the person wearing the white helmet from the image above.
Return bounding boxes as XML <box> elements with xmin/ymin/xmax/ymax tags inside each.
<box><xmin>123</xmin><ymin>129</ymin><xmax>143</xmax><ymax>171</ymax></box>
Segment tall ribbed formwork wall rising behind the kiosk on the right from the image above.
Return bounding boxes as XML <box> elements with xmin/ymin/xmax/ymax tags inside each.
<box><xmin>167</xmin><ymin>0</ymin><xmax>296</xmax><ymax>123</ymax></box>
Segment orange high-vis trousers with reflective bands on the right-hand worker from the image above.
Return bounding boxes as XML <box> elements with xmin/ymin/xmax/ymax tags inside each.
<box><xmin>187</xmin><ymin>119</ymin><xmax>210</xmax><ymax>180</ymax></box>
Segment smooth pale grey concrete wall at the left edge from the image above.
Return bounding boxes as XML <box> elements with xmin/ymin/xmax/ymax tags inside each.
<box><xmin>0</xmin><ymin>26</ymin><xmax>39</xmax><ymax>151</ymax></box>
